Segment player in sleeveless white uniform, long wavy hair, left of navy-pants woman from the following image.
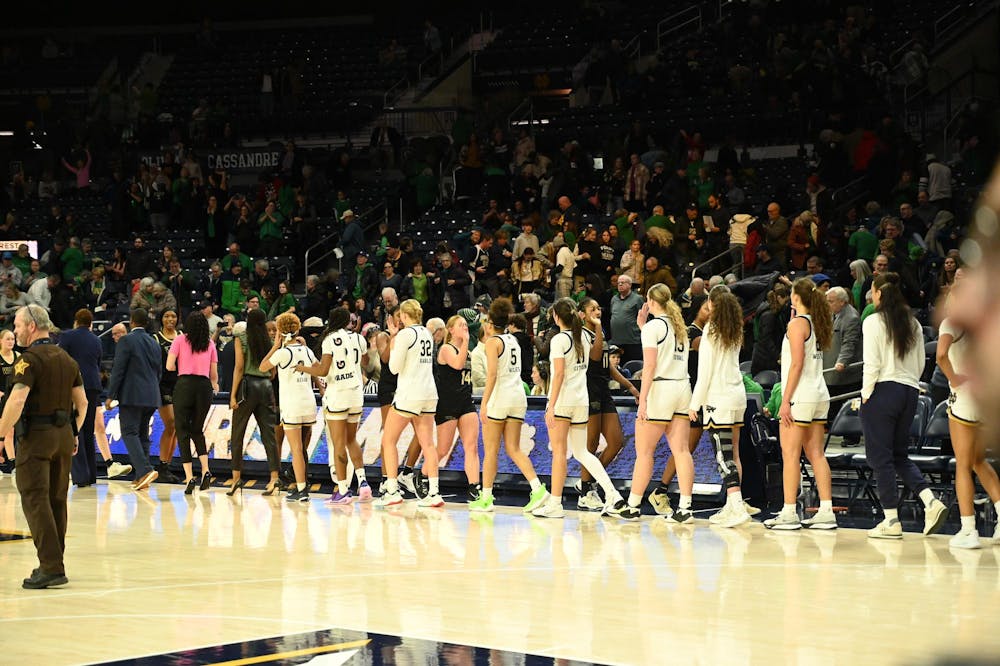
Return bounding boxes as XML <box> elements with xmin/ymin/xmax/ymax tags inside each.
<box><xmin>764</xmin><ymin>278</ymin><xmax>837</xmax><ymax>530</ymax></box>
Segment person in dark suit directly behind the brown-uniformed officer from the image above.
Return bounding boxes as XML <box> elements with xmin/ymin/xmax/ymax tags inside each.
<box><xmin>59</xmin><ymin>309</ymin><xmax>103</xmax><ymax>488</ymax></box>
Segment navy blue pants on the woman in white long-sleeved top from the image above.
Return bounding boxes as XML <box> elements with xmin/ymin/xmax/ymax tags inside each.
<box><xmin>861</xmin><ymin>382</ymin><xmax>930</xmax><ymax>509</ymax></box>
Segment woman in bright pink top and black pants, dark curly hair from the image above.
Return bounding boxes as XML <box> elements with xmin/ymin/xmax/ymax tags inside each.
<box><xmin>167</xmin><ymin>310</ymin><xmax>219</xmax><ymax>495</ymax></box>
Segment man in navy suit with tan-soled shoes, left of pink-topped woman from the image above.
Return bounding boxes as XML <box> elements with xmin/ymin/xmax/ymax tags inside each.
<box><xmin>105</xmin><ymin>308</ymin><xmax>162</xmax><ymax>490</ymax></box>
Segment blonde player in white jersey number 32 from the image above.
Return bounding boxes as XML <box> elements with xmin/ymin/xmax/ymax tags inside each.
<box><xmin>375</xmin><ymin>298</ymin><xmax>444</xmax><ymax>507</ymax></box>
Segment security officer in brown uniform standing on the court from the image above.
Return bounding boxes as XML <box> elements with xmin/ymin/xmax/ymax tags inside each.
<box><xmin>0</xmin><ymin>305</ymin><xmax>87</xmax><ymax>590</ymax></box>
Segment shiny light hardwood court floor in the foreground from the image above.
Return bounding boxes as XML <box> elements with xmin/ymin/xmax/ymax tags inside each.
<box><xmin>0</xmin><ymin>477</ymin><xmax>1000</xmax><ymax>664</ymax></box>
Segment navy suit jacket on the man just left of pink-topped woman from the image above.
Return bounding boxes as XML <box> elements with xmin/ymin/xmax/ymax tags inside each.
<box><xmin>108</xmin><ymin>328</ymin><xmax>163</xmax><ymax>407</ymax></box>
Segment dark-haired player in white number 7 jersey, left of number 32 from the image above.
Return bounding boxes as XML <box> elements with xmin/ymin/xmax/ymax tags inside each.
<box><xmin>295</xmin><ymin>307</ymin><xmax>372</xmax><ymax>504</ymax></box>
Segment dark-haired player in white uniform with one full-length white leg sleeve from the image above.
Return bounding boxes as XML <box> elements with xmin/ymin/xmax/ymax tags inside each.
<box><xmin>531</xmin><ymin>298</ymin><xmax>625</xmax><ymax>518</ymax></box>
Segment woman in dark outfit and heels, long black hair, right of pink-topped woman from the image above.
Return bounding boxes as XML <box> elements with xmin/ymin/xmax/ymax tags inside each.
<box><xmin>227</xmin><ymin>310</ymin><xmax>279</xmax><ymax>495</ymax></box>
